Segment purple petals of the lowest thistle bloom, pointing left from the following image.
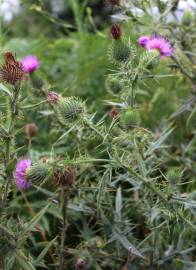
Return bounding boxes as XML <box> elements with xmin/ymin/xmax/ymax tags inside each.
<box><xmin>14</xmin><ymin>159</ymin><xmax>31</xmax><ymax>189</ymax></box>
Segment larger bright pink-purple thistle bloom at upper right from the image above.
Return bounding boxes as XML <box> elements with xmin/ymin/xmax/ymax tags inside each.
<box><xmin>145</xmin><ymin>36</ymin><xmax>174</xmax><ymax>57</ymax></box>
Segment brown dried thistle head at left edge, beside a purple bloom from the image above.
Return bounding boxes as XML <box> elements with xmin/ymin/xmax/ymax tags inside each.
<box><xmin>0</xmin><ymin>52</ymin><xmax>24</xmax><ymax>85</ymax></box>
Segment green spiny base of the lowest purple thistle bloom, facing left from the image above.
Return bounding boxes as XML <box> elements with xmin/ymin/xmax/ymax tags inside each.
<box><xmin>25</xmin><ymin>163</ymin><xmax>49</xmax><ymax>183</ymax></box>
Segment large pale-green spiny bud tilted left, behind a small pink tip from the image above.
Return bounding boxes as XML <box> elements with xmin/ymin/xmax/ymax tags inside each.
<box><xmin>53</xmin><ymin>97</ymin><xmax>84</xmax><ymax>125</ymax></box>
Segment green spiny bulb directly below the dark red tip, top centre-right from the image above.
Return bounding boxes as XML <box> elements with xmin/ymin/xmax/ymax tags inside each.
<box><xmin>112</xmin><ymin>39</ymin><xmax>131</xmax><ymax>63</ymax></box>
